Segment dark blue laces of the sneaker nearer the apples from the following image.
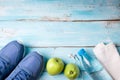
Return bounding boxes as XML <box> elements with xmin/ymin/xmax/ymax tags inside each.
<box><xmin>12</xmin><ymin>70</ymin><xmax>30</xmax><ymax>80</ymax></box>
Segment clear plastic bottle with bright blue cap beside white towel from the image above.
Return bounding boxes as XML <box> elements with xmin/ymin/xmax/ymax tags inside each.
<box><xmin>77</xmin><ymin>49</ymin><xmax>113</xmax><ymax>80</ymax></box>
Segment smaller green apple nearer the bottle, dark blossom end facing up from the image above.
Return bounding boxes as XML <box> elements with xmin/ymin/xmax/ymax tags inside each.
<box><xmin>64</xmin><ymin>63</ymin><xmax>80</xmax><ymax>79</ymax></box>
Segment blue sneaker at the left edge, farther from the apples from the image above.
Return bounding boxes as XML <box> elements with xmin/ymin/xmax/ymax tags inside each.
<box><xmin>0</xmin><ymin>41</ymin><xmax>24</xmax><ymax>80</ymax></box>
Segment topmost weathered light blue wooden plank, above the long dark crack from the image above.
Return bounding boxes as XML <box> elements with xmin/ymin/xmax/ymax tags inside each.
<box><xmin>0</xmin><ymin>0</ymin><xmax>120</xmax><ymax>21</ymax></box>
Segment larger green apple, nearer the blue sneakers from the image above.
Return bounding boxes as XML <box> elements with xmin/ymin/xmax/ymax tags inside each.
<box><xmin>46</xmin><ymin>57</ymin><xmax>64</xmax><ymax>75</ymax></box>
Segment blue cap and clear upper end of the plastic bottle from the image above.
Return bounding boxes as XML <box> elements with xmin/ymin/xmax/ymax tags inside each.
<box><xmin>78</xmin><ymin>49</ymin><xmax>103</xmax><ymax>73</ymax></box>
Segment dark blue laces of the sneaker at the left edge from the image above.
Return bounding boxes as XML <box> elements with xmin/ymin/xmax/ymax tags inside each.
<box><xmin>0</xmin><ymin>58</ymin><xmax>9</xmax><ymax>75</ymax></box>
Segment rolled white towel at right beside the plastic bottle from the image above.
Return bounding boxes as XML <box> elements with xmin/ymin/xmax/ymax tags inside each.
<box><xmin>93</xmin><ymin>43</ymin><xmax>120</xmax><ymax>80</ymax></box>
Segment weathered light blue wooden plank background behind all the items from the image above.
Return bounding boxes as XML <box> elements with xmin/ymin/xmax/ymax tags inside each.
<box><xmin>0</xmin><ymin>0</ymin><xmax>120</xmax><ymax>80</ymax></box>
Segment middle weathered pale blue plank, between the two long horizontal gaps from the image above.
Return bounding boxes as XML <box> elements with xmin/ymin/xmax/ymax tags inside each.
<box><xmin>0</xmin><ymin>21</ymin><xmax>120</xmax><ymax>47</ymax></box>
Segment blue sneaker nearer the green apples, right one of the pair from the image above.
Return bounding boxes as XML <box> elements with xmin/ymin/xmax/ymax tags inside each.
<box><xmin>5</xmin><ymin>52</ymin><xmax>44</xmax><ymax>80</ymax></box>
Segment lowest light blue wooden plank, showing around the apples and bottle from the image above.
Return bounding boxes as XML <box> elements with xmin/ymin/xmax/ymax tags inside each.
<box><xmin>26</xmin><ymin>47</ymin><xmax>120</xmax><ymax>80</ymax></box>
